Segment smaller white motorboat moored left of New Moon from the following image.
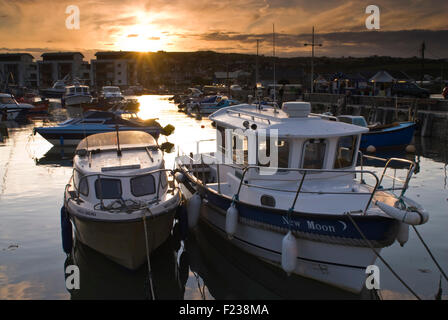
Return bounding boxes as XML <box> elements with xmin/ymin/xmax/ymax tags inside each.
<box><xmin>64</xmin><ymin>131</ymin><xmax>180</xmax><ymax>270</ymax></box>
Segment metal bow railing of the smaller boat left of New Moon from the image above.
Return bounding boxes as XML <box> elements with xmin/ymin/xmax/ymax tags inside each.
<box><xmin>66</xmin><ymin>168</ymin><xmax>174</xmax><ymax>209</ymax></box>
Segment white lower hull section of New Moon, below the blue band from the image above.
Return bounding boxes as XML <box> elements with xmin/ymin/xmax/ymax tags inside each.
<box><xmin>201</xmin><ymin>205</ymin><xmax>374</xmax><ymax>293</ymax></box>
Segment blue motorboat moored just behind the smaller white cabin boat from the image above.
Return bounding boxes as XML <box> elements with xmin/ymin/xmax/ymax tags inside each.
<box><xmin>34</xmin><ymin>111</ymin><xmax>162</xmax><ymax>146</ymax></box>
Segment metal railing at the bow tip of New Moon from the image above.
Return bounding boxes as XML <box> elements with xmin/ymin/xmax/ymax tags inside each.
<box><xmin>358</xmin><ymin>151</ymin><xmax>416</xmax><ymax>197</ymax></box>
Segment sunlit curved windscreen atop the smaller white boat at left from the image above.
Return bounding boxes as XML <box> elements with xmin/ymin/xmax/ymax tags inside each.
<box><xmin>76</xmin><ymin>131</ymin><xmax>157</xmax><ymax>150</ymax></box>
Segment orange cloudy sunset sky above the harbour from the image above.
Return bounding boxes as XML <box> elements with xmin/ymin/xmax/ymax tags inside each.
<box><xmin>0</xmin><ymin>0</ymin><xmax>448</xmax><ymax>59</ymax></box>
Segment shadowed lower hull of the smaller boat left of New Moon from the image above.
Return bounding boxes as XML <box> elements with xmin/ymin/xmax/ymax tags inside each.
<box><xmin>69</xmin><ymin>208</ymin><xmax>176</xmax><ymax>270</ymax></box>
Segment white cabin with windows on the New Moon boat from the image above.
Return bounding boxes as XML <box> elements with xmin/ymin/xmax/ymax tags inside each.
<box><xmin>210</xmin><ymin>102</ymin><xmax>368</xmax><ymax>175</ymax></box>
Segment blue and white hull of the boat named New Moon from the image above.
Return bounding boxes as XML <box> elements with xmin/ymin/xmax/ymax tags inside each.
<box><xmin>180</xmin><ymin>173</ymin><xmax>398</xmax><ymax>293</ymax></box>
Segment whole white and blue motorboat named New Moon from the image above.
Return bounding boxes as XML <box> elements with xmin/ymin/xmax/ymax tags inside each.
<box><xmin>176</xmin><ymin>102</ymin><xmax>428</xmax><ymax>292</ymax></box>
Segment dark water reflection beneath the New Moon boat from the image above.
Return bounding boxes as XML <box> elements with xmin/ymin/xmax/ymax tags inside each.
<box><xmin>185</xmin><ymin>223</ymin><xmax>378</xmax><ymax>300</ymax></box>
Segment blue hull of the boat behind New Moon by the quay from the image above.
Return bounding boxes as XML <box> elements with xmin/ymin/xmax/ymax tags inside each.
<box><xmin>360</xmin><ymin>122</ymin><xmax>415</xmax><ymax>149</ymax></box>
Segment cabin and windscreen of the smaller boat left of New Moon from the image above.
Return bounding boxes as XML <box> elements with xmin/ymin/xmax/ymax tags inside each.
<box><xmin>72</xmin><ymin>131</ymin><xmax>168</xmax><ymax>206</ymax></box>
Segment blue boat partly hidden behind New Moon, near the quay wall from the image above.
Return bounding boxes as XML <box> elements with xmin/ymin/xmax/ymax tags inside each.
<box><xmin>337</xmin><ymin>115</ymin><xmax>415</xmax><ymax>149</ymax></box>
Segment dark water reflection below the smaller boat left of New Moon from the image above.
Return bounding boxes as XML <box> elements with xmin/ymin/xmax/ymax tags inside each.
<box><xmin>64</xmin><ymin>237</ymin><xmax>184</xmax><ymax>300</ymax></box>
